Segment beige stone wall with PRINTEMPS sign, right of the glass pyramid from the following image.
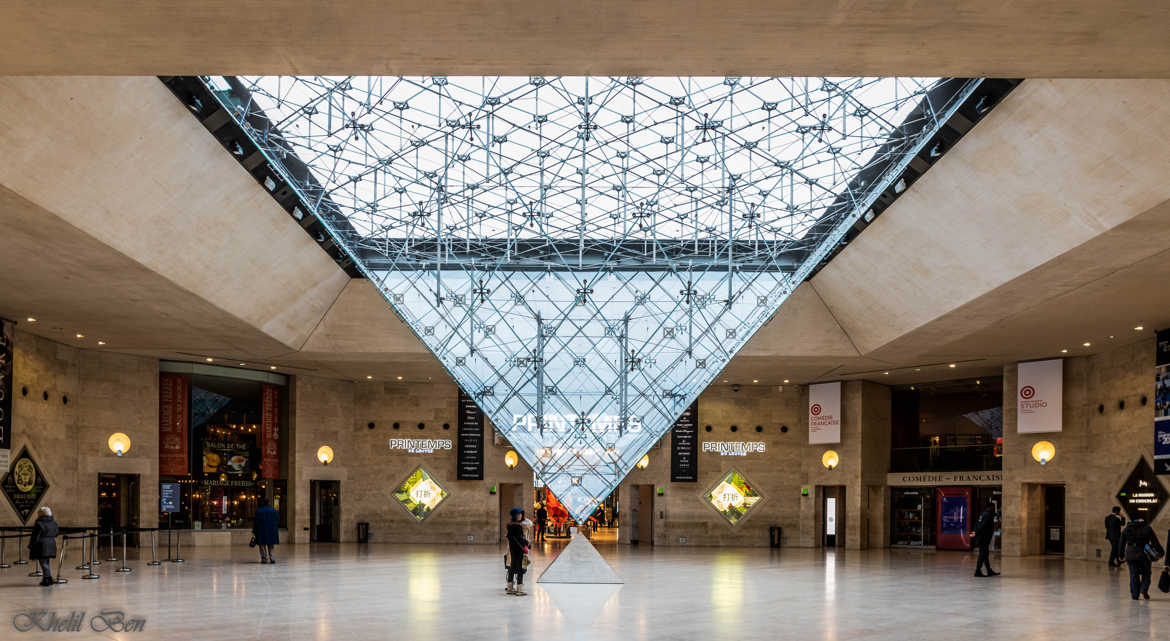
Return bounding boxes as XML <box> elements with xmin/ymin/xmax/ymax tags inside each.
<box><xmin>619</xmin><ymin>381</ymin><xmax>889</xmax><ymax>549</ymax></box>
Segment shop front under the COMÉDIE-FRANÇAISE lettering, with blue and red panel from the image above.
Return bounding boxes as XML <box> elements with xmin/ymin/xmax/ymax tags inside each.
<box><xmin>886</xmin><ymin>470</ymin><xmax>1004</xmax><ymax>550</ymax></box>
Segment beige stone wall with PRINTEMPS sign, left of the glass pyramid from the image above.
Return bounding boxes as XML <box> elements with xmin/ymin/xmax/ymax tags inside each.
<box><xmin>289</xmin><ymin>375</ymin><xmax>532</xmax><ymax>544</ymax></box>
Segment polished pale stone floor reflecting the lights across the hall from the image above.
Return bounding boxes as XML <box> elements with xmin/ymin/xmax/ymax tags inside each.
<box><xmin>0</xmin><ymin>544</ymin><xmax>1170</xmax><ymax>641</ymax></box>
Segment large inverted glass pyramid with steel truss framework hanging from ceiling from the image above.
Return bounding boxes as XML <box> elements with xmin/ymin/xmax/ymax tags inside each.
<box><xmin>204</xmin><ymin>76</ymin><xmax>979</xmax><ymax>519</ymax></box>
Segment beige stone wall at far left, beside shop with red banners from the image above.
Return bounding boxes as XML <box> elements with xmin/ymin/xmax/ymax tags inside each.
<box><xmin>0</xmin><ymin>330</ymin><xmax>158</xmax><ymax>528</ymax></box>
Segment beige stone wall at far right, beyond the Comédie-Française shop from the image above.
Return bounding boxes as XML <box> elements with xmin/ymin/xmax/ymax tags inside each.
<box><xmin>1003</xmin><ymin>338</ymin><xmax>1170</xmax><ymax>561</ymax></box>
